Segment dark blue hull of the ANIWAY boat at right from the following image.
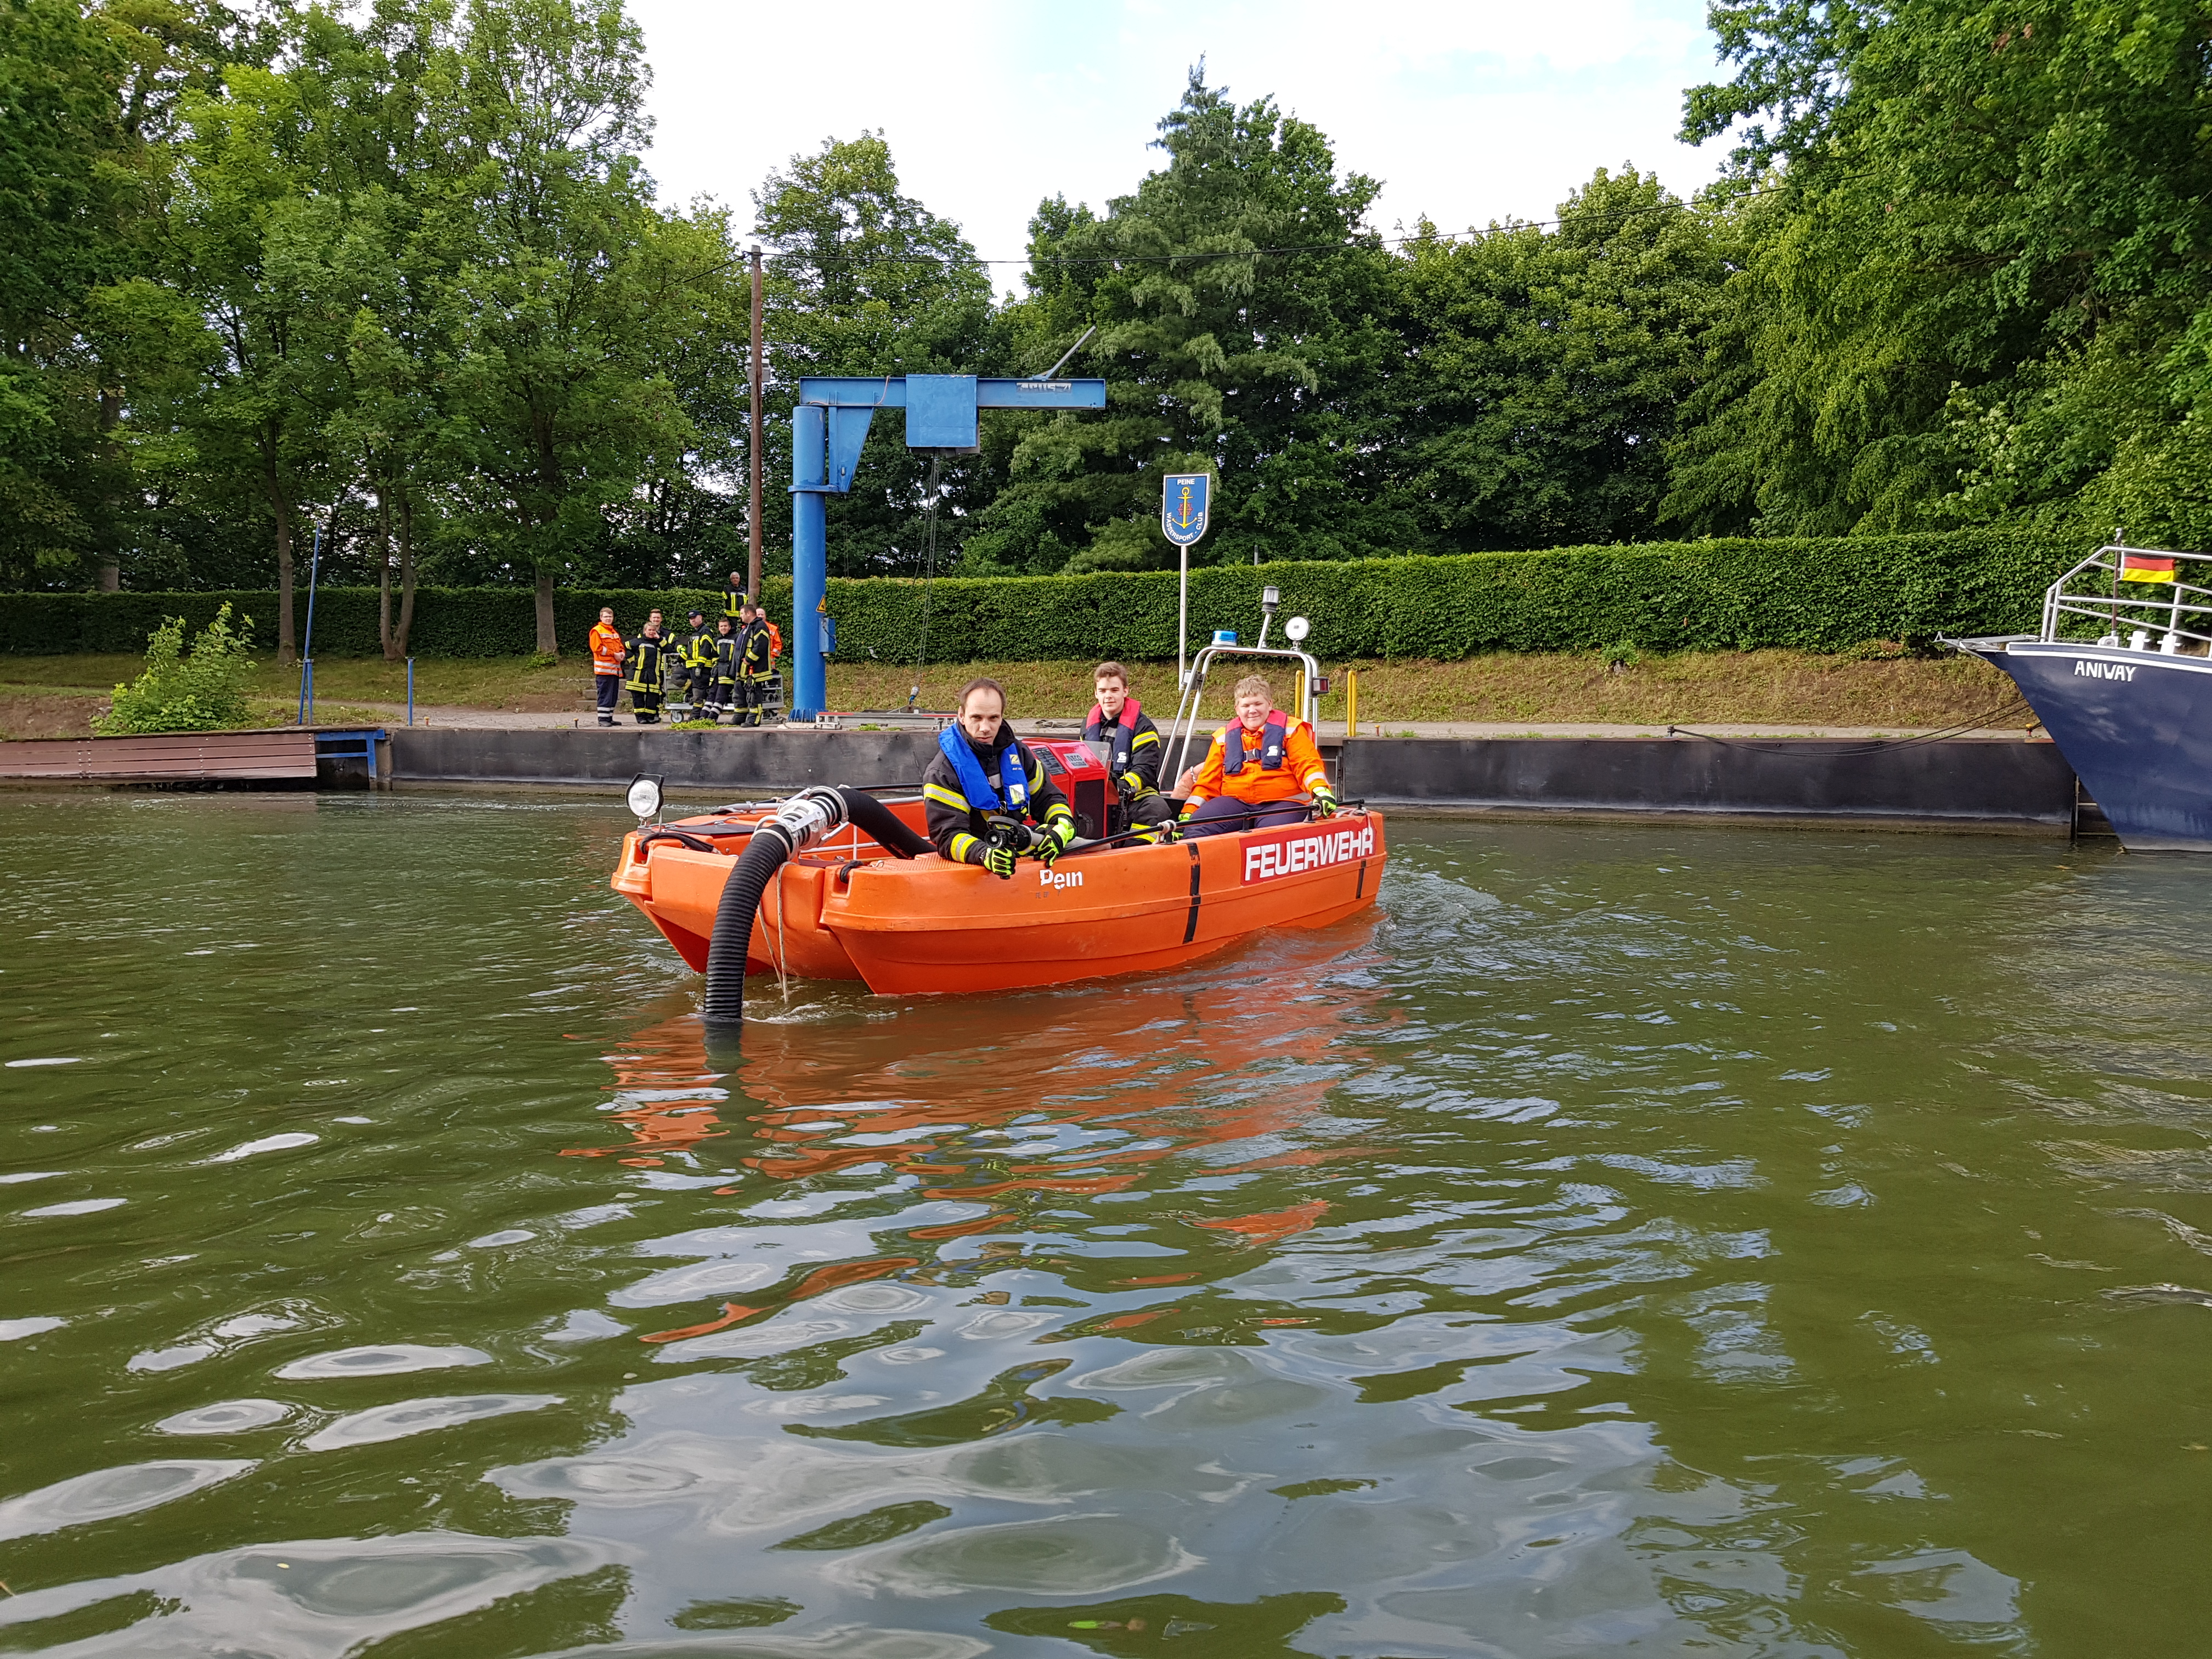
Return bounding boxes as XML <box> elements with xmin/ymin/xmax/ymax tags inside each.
<box><xmin>1976</xmin><ymin>639</ymin><xmax>2212</xmax><ymax>851</ymax></box>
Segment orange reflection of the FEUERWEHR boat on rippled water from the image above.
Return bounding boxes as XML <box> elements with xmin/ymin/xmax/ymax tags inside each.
<box><xmin>571</xmin><ymin>938</ymin><xmax>1376</xmax><ymax>1342</ymax></box>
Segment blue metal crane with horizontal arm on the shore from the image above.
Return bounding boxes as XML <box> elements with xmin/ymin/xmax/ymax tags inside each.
<box><xmin>792</xmin><ymin>374</ymin><xmax>1106</xmax><ymax>721</ymax></box>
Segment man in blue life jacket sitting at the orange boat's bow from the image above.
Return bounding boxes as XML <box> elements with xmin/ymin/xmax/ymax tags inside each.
<box><xmin>922</xmin><ymin>679</ymin><xmax>1075</xmax><ymax>881</ymax></box>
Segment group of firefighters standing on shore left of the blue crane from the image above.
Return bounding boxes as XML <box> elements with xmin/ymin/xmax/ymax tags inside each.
<box><xmin>591</xmin><ymin>571</ymin><xmax>783</xmax><ymax>725</ymax></box>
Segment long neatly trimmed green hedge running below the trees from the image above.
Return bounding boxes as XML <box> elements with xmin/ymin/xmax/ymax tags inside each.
<box><xmin>0</xmin><ymin>531</ymin><xmax>2081</xmax><ymax>662</ymax></box>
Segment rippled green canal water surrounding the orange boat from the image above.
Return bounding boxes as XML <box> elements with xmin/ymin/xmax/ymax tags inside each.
<box><xmin>0</xmin><ymin>794</ymin><xmax>2212</xmax><ymax>1659</ymax></box>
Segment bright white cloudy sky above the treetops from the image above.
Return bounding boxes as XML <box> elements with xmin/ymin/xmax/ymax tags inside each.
<box><xmin>630</xmin><ymin>0</ymin><xmax>1725</xmax><ymax>287</ymax></box>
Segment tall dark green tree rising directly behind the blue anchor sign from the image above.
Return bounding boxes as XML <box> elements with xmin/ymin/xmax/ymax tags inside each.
<box><xmin>964</xmin><ymin>71</ymin><xmax>1407</xmax><ymax>573</ymax></box>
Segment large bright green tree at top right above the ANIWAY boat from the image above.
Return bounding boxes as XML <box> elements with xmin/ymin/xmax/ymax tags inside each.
<box><xmin>1668</xmin><ymin>0</ymin><xmax>2212</xmax><ymax>546</ymax></box>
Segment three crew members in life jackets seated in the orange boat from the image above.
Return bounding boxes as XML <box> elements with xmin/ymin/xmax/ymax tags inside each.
<box><xmin>922</xmin><ymin>662</ymin><xmax>1336</xmax><ymax>878</ymax></box>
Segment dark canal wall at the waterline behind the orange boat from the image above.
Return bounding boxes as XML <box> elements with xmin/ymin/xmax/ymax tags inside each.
<box><xmin>392</xmin><ymin>725</ymin><xmax>2075</xmax><ymax>836</ymax></box>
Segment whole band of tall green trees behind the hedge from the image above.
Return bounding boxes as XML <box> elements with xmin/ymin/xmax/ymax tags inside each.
<box><xmin>0</xmin><ymin>0</ymin><xmax>2212</xmax><ymax>606</ymax></box>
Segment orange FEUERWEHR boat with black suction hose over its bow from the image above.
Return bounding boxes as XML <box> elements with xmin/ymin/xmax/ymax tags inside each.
<box><xmin>613</xmin><ymin>761</ymin><xmax>1385</xmax><ymax>1024</ymax></box>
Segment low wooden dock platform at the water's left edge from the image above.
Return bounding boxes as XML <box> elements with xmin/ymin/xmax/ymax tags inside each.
<box><xmin>0</xmin><ymin>725</ymin><xmax>392</xmax><ymax>787</ymax></box>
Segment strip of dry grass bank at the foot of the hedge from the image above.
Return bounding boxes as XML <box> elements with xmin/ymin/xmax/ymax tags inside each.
<box><xmin>0</xmin><ymin>650</ymin><xmax>2030</xmax><ymax>737</ymax></box>
